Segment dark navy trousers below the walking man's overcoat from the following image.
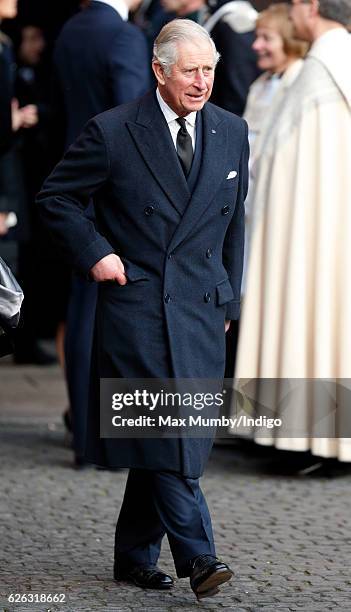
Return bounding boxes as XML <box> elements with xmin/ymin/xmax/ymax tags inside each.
<box><xmin>115</xmin><ymin>469</ymin><xmax>215</xmax><ymax>578</ymax></box>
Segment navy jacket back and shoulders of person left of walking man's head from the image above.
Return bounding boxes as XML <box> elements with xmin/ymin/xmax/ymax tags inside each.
<box><xmin>53</xmin><ymin>2</ymin><xmax>150</xmax><ymax>147</ymax></box>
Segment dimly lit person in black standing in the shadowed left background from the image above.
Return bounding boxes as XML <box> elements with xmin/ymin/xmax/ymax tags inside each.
<box><xmin>9</xmin><ymin>24</ymin><xmax>58</xmax><ymax>366</ymax></box>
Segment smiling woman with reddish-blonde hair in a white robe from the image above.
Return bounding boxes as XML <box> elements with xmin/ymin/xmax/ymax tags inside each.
<box><xmin>242</xmin><ymin>3</ymin><xmax>308</xmax><ymax>294</ymax></box>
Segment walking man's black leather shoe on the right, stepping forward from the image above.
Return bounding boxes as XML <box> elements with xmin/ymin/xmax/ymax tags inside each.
<box><xmin>190</xmin><ymin>555</ymin><xmax>233</xmax><ymax>600</ymax></box>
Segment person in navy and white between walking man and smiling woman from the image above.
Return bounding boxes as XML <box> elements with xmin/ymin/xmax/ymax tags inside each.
<box><xmin>205</xmin><ymin>0</ymin><xmax>260</xmax><ymax>116</ymax></box>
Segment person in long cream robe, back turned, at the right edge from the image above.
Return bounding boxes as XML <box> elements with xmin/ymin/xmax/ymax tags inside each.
<box><xmin>234</xmin><ymin>0</ymin><xmax>351</xmax><ymax>468</ymax></box>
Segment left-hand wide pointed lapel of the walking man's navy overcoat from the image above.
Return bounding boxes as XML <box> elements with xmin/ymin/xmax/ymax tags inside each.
<box><xmin>127</xmin><ymin>92</ymin><xmax>190</xmax><ymax>215</ymax></box>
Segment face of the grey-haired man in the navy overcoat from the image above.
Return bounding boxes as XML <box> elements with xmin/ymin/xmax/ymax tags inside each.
<box><xmin>153</xmin><ymin>39</ymin><xmax>215</xmax><ymax>117</ymax></box>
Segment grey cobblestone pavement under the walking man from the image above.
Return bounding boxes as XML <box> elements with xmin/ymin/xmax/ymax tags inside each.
<box><xmin>0</xmin><ymin>363</ymin><xmax>351</xmax><ymax>612</ymax></box>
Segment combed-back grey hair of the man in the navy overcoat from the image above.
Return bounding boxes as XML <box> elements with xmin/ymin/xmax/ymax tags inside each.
<box><xmin>152</xmin><ymin>19</ymin><xmax>220</xmax><ymax>76</ymax></box>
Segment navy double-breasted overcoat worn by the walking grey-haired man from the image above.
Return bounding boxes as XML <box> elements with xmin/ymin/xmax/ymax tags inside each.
<box><xmin>38</xmin><ymin>92</ymin><xmax>248</xmax><ymax>478</ymax></box>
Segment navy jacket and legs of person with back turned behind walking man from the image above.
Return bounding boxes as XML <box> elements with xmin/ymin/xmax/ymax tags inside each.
<box><xmin>53</xmin><ymin>2</ymin><xmax>150</xmax><ymax>462</ymax></box>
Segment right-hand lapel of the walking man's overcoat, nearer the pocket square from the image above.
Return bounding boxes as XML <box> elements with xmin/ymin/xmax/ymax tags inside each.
<box><xmin>168</xmin><ymin>104</ymin><xmax>229</xmax><ymax>250</ymax></box>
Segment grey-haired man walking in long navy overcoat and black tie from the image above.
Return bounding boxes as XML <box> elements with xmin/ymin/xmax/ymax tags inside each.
<box><xmin>38</xmin><ymin>20</ymin><xmax>248</xmax><ymax>599</ymax></box>
